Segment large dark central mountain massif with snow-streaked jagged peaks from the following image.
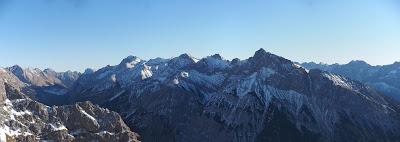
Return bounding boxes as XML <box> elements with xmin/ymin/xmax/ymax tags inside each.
<box><xmin>70</xmin><ymin>49</ymin><xmax>400</xmax><ymax>142</ymax></box>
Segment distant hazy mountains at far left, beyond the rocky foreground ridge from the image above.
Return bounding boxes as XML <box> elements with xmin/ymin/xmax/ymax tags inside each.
<box><xmin>5</xmin><ymin>65</ymin><xmax>80</xmax><ymax>105</ymax></box>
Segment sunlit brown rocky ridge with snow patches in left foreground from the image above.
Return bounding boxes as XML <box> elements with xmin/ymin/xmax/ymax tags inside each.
<box><xmin>0</xmin><ymin>83</ymin><xmax>138</xmax><ymax>142</ymax></box>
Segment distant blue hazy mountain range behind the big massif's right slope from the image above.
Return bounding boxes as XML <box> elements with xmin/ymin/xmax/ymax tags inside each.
<box><xmin>301</xmin><ymin>61</ymin><xmax>400</xmax><ymax>101</ymax></box>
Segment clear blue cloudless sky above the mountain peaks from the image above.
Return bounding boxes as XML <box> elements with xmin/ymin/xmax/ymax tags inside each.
<box><xmin>0</xmin><ymin>0</ymin><xmax>400</xmax><ymax>71</ymax></box>
